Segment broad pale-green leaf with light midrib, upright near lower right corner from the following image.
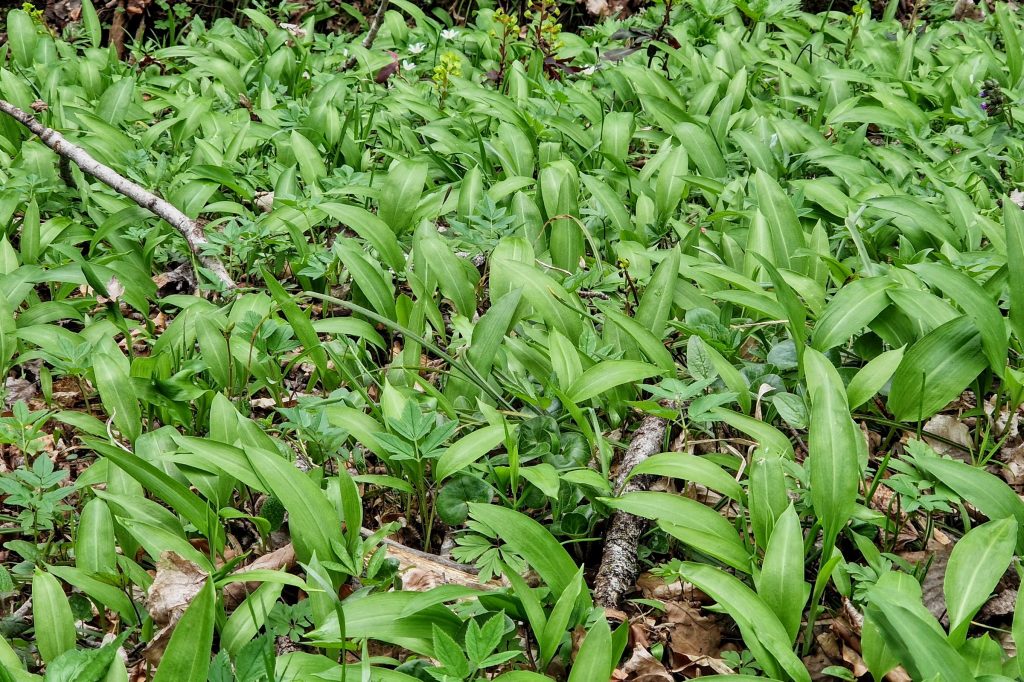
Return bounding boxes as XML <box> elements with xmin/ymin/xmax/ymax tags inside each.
<box><xmin>942</xmin><ymin>516</ymin><xmax>1017</xmax><ymax>646</ymax></box>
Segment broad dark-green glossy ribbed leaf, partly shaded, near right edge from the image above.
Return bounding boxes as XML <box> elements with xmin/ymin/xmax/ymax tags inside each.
<box><xmin>889</xmin><ymin>316</ymin><xmax>986</xmax><ymax>422</ymax></box>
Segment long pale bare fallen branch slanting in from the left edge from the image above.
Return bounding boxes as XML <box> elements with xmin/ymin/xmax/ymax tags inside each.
<box><xmin>0</xmin><ymin>99</ymin><xmax>234</xmax><ymax>289</ymax></box>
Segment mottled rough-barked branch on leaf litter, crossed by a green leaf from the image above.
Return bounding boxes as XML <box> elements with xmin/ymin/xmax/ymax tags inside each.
<box><xmin>594</xmin><ymin>409</ymin><xmax>668</xmax><ymax>608</ymax></box>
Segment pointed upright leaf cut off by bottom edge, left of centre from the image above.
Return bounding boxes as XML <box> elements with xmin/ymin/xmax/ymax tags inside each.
<box><xmin>153</xmin><ymin>579</ymin><xmax>216</xmax><ymax>682</ymax></box>
